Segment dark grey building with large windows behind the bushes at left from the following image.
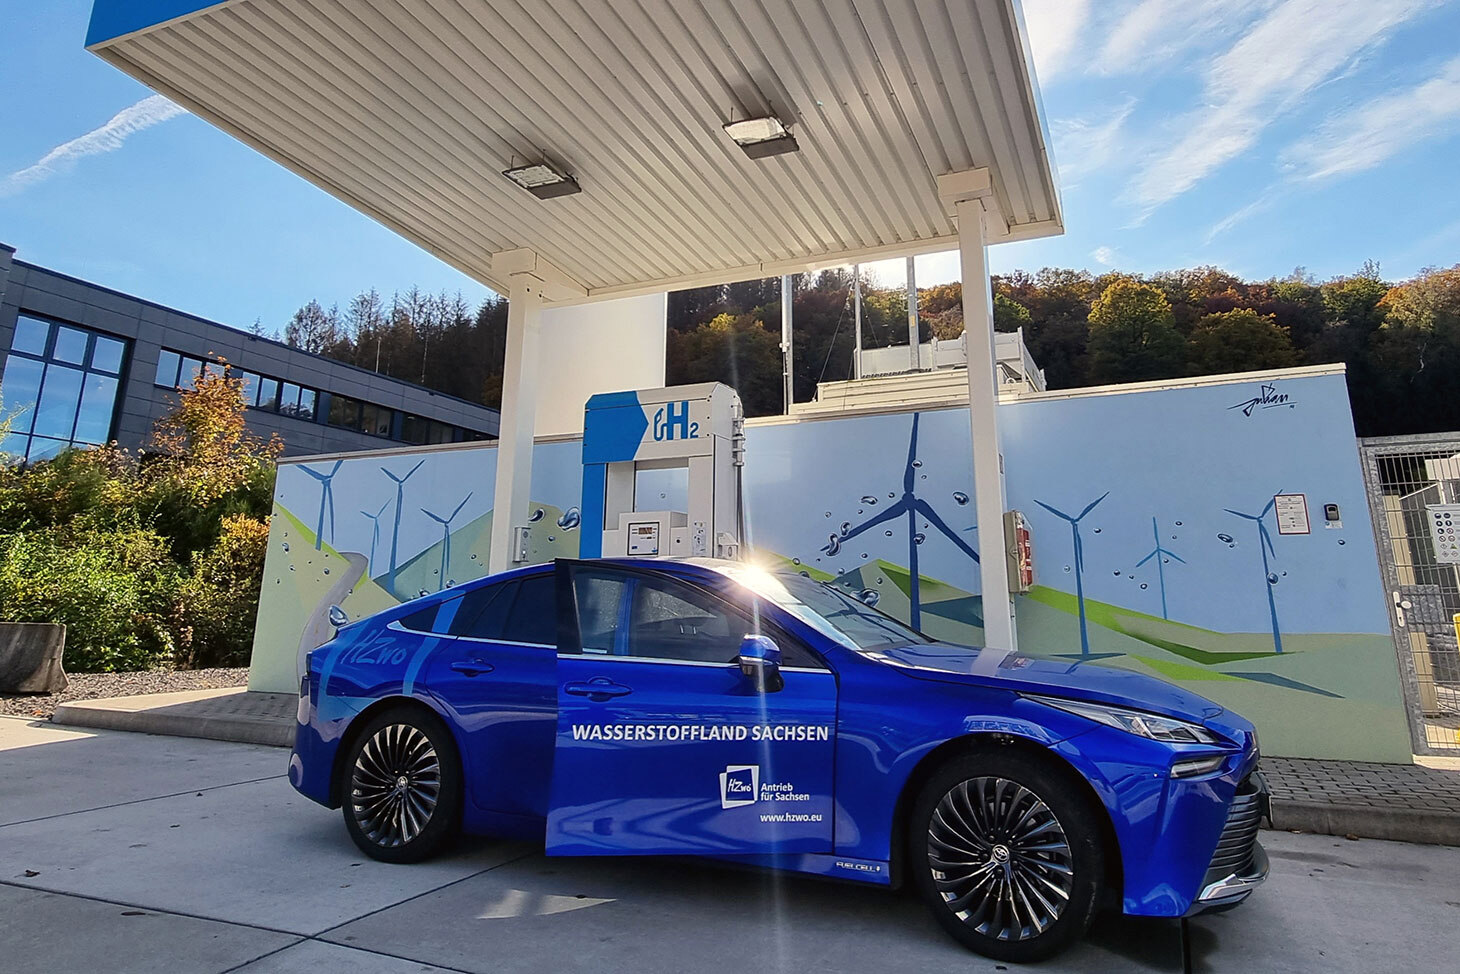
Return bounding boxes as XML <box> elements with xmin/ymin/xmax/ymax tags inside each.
<box><xmin>0</xmin><ymin>244</ymin><xmax>498</xmax><ymax>461</ymax></box>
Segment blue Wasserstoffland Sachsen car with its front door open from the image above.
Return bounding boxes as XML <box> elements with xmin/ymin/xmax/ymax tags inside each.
<box><xmin>289</xmin><ymin>559</ymin><xmax>1267</xmax><ymax>961</ymax></box>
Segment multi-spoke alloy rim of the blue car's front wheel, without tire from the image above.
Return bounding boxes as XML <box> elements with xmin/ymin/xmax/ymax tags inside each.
<box><xmin>927</xmin><ymin>777</ymin><xmax>1075</xmax><ymax>940</ymax></box>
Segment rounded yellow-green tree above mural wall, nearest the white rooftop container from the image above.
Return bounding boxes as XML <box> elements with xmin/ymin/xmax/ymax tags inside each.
<box><xmin>1089</xmin><ymin>277</ymin><xmax>1186</xmax><ymax>383</ymax></box>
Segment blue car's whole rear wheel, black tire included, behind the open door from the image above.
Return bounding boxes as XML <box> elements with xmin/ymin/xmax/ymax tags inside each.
<box><xmin>340</xmin><ymin>707</ymin><xmax>463</xmax><ymax>863</ymax></box>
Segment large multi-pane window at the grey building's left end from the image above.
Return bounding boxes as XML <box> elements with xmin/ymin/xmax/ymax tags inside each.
<box><xmin>0</xmin><ymin>315</ymin><xmax>127</xmax><ymax>461</ymax></box>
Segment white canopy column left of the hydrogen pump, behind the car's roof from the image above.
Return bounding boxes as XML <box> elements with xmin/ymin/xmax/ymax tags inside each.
<box><xmin>488</xmin><ymin>273</ymin><xmax>543</xmax><ymax>574</ymax></box>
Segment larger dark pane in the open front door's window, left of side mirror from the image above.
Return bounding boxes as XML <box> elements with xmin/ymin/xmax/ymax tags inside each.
<box><xmin>628</xmin><ymin>578</ymin><xmax>753</xmax><ymax>663</ymax></box>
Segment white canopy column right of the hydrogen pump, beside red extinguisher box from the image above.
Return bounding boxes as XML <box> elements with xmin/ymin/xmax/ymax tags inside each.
<box><xmin>955</xmin><ymin>196</ymin><xmax>1018</xmax><ymax>650</ymax></box>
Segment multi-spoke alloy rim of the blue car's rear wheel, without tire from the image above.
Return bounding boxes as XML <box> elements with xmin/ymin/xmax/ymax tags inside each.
<box><xmin>350</xmin><ymin>724</ymin><xmax>441</xmax><ymax>848</ymax></box>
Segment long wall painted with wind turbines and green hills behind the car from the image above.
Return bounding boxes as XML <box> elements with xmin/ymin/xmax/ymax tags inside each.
<box><xmin>251</xmin><ymin>374</ymin><xmax>1410</xmax><ymax>761</ymax></box>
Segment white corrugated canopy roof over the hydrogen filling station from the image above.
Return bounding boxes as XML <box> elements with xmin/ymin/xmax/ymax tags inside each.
<box><xmin>88</xmin><ymin>0</ymin><xmax>1063</xmax><ymax>299</ymax></box>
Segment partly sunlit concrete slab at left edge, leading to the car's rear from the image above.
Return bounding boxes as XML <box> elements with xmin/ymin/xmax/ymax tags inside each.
<box><xmin>0</xmin><ymin>717</ymin><xmax>288</xmax><ymax>829</ymax></box>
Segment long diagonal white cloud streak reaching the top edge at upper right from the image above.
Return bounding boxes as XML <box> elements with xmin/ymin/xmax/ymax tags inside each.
<box><xmin>1132</xmin><ymin>0</ymin><xmax>1435</xmax><ymax>215</ymax></box>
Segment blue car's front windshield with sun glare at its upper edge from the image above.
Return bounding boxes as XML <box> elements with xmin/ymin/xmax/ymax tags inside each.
<box><xmin>718</xmin><ymin>565</ymin><xmax>930</xmax><ymax>650</ymax></box>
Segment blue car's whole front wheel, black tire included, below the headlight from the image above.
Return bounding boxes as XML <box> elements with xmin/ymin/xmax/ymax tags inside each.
<box><xmin>908</xmin><ymin>748</ymin><xmax>1105</xmax><ymax>964</ymax></box>
